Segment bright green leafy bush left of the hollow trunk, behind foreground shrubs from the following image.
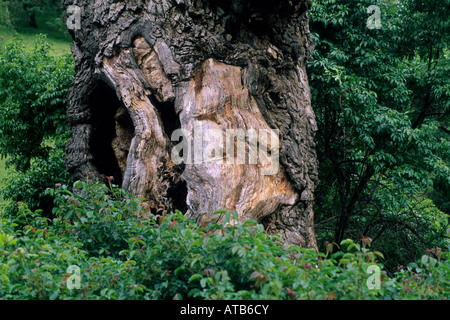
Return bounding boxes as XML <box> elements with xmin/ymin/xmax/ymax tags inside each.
<box><xmin>0</xmin><ymin>36</ymin><xmax>73</xmax><ymax>212</ymax></box>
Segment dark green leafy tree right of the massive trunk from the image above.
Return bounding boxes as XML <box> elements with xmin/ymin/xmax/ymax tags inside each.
<box><xmin>308</xmin><ymin>0</ymin><xmax>450</xmax><ymax>269</ymax></box>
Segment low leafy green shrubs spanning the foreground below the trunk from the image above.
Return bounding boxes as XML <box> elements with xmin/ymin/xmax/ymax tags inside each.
<box><xmin>0</xmin><ymin>182</ymin><xmax>450</xmax><ymax>300</ymax></box>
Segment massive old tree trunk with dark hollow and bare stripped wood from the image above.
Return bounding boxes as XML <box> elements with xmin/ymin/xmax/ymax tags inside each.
<box><xmin>62</xmin><ymin>0</ymin><xmax>317</xmax><ymax>247</ymax></box>
